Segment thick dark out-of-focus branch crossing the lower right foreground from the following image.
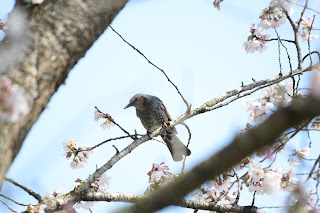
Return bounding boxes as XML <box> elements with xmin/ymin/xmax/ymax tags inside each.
<box><xmin>123</xmin><ymin>97</ymin><xmax>320</xmax><ymax>213</ymax></box>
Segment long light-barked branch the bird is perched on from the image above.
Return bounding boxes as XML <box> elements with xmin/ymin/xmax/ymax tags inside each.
<box><xmin>38</xmin><ymin>63</ymin><xmax>320</xmax><ymax>210</ymax></box>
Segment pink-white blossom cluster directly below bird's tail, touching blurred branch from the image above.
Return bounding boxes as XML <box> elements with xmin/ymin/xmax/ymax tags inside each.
<box><xmin>145</xmin><ymin>162</ymin><xmax>179</xmax><ymax>194</ymax></box>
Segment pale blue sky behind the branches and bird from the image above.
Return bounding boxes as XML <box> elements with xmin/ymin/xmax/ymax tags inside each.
<box><xmin>0</xmin><ymin>0</ymin><xmax>319</xmax><ymax>212</ymax></box>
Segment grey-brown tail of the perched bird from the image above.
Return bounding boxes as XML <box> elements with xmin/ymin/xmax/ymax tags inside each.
<box><xmin>161</xmin><ymin>129</ymin><xmax>191</xmax><ymax>161</ymax></box>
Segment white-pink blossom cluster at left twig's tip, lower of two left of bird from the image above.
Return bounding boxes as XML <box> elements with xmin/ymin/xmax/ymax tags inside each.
<box><xmin>63</xmin><ymin>137</ymin><xmax>93</xmax><ymax>169</ymax></box>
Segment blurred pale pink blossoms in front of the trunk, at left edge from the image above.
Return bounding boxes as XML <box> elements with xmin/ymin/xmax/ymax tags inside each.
<box><xmin>0</xmin><ymin>78</ymin><xmax>30</xmax><ymax>123</ymax></box>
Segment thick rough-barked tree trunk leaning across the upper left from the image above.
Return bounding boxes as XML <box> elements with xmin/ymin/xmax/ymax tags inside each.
<box><xmin>0</xmin><ymin>0</ymin><xmax>128</xmax><ymax>186</ymax></box>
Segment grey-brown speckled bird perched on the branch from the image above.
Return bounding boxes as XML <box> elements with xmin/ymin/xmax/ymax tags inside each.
<box><xmin>124</xmin><ymin>93</ymin><xmax>191</xmax><ymax>161</ymax></box>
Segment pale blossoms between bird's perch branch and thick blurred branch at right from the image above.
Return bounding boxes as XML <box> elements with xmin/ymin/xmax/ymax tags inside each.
<box><xmin>243</xmin><ymin>82</ymin><xmax>293</xmax><ymax>121</ymax></box>
